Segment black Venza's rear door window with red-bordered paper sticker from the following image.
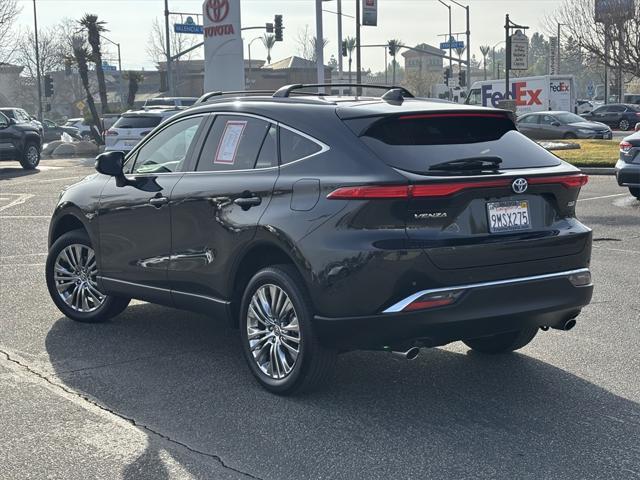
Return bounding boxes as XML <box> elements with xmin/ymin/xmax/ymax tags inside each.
<box><xmin>197</xmin><ymin>115</ymin><xmax>271</xmax><ymax>172</ymax></box>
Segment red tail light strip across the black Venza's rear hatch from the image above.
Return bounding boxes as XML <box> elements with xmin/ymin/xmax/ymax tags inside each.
<box><xmin>327</xmin><ymin>173</ymin><xmax>589</xmax><ymax>200</ymax></box>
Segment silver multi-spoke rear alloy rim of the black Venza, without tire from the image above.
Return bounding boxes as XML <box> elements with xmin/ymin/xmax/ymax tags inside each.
<box><xmin>247</xmin><ymin>284</ymin><xmax>301</xmax><ymax>380</ymax></box>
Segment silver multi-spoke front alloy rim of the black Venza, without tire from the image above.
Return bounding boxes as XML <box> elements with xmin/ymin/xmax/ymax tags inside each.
<box><xmin>53</xmin><ymin>243</ymin><xmax>105</xmax><ymax>313</ymax></box>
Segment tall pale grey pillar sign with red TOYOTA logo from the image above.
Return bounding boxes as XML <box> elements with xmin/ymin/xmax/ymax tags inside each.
<box><xmin>202</xmin><ymin>0</ymin><xmax>244</xmax><ymax>92</ymax></box>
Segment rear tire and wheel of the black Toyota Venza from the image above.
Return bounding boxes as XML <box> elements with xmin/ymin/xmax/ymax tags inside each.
<box><xmin>239</xmin><ymin>265</ymin><xmax>337</xmax><ymax>395</ymax></box>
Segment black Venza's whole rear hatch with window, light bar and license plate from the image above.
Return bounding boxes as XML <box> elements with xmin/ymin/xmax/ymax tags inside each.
<box><xmin>343</xmin><ymin>109</ymin><xmax>589</xmax><ymax>280</ymax></box>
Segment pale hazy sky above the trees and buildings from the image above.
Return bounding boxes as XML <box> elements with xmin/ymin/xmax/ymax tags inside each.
<box><xmin>19</xmin><ymin>0</ymin><xmax>562</xmax><ymax>71</ymax></box>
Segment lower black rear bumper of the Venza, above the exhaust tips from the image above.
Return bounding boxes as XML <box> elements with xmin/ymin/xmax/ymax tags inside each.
<box><xmin>314</xmin><ymin>271</ymin><xmax>593</xmax><ymax>350</ymax></box>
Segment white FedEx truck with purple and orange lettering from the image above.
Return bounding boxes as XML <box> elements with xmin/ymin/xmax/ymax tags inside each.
<box><xmin>465</xmin><ymin>75</ymin><xmax>576</xmax><ymax>115</ymax></box>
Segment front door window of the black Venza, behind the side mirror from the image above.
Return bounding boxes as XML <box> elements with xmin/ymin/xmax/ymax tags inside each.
<box><xmin>130</xmin><ymin>117</ymin><xmax>203</xmax><ymax>174</ymax></box>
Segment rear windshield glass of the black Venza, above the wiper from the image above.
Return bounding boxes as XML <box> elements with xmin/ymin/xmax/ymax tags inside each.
<box><xmin>347</xmin><ymin>114</ymin><xmax>560</xmax><ymax>173</ymax></box>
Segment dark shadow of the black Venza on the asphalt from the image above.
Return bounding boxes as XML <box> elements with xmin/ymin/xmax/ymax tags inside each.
<box><xmin>46</xmin><ymin>304</ymin><xmax>640</xmax><ymax>479</ymax></box>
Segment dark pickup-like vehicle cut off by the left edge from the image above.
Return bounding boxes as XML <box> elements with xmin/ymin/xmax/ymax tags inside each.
<box><xmin>0</xmin><ymin>112</ymin><xmax>42</xmax><ymax>170</ymax></box>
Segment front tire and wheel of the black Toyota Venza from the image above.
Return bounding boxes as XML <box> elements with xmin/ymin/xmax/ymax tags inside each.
<box><xmin>45</xmin><ymin>230</ymin><xmax>131</xmax><ymax>323</ymax></box>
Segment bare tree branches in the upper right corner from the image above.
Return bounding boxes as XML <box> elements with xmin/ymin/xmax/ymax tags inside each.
<box><xmin>546</xmin><ymin>0</ymin><xmax>640</xmax><ymax>76</ymax></box>
